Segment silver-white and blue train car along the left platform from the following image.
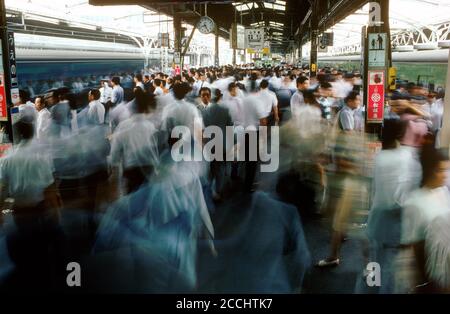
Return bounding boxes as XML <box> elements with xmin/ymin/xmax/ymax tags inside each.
<box><xmin>15</xmin><ymin>33</ymin><xmax>145</xmax><ymax>94</ymax></box>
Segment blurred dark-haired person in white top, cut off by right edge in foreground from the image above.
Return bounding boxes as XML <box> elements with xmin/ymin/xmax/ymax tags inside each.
<box><xmin>400</xmin><ymin>139</ymin><xmax>450</xmax><ymax>292</ymax></box>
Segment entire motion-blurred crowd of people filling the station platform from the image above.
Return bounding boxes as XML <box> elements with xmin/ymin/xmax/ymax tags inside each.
<box><xmin>0</xmin><ymin>65</ymin><xmax>450</xmax><ymax>293</ymax></box>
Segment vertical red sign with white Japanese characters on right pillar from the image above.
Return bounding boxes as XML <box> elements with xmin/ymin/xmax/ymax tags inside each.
<box><xmin>367</xmin><ymin>70</ymin><xmax>385</xmax><ymax>123</ymax></box>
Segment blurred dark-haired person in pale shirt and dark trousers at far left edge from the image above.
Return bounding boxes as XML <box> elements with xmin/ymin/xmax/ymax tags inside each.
<box><xmin>0</xmin><ymin>120</ymin><xmax>64</xmax><ymax>280</ymax></box>
